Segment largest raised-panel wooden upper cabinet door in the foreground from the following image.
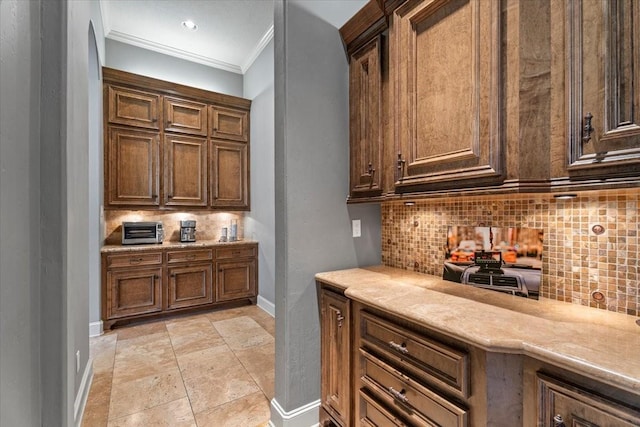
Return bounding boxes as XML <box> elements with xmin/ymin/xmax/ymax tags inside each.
<box><xmin>390</xmin><ymin>0</ymin><xmax>505</xmax><ymax>192</ymax></box>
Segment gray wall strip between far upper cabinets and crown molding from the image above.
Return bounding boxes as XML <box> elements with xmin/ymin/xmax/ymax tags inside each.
<box><xmin>105</xmin><ymin>39</ymin><xmax>243</xmax><ymax>96</ymax></box>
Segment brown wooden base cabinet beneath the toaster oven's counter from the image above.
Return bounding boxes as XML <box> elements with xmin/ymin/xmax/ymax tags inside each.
<box><xmin>102</xmin><ymin>243</ymin><xmax>258</xmax><ymax>329</ymax></box>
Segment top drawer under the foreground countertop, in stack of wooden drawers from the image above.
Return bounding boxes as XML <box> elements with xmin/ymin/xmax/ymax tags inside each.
<box><xmin>360</xmin><ymin>312</ymin><xmax>469</xmax><ymax>398</ymax></box>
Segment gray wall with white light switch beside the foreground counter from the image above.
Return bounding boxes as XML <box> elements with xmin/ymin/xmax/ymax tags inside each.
<box><xmin>274</xmin><ymin>0</ymin><xmax>380</xmax><ymax>412</ymax></box>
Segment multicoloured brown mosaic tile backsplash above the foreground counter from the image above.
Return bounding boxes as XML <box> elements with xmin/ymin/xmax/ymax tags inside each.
<box><xmin>382</xmin><ymin>189</ymin><xmax>640</xmax><ymax>316</ymax></box>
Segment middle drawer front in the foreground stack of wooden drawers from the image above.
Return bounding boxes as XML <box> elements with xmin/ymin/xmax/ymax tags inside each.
<box><xmin>360</xmin><ymin>349</ymin><xmax>468</xmax><ymax>427</ymax></box>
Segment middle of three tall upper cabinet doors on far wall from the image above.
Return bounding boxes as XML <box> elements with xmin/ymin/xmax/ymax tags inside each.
<box><xmin>164</xmin><ymin>134</ymin><xmax>208</xmax><ymax>207</ymax></box>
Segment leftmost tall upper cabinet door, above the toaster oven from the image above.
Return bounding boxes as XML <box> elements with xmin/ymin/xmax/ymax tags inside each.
<box><xmin>105</xmin><ymin>128</ymin><xmax>160</xmax><ymax>206</ymax></box>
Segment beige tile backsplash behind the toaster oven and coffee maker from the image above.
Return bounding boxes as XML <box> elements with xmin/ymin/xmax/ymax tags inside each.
<box><xmin>104</xmin><ymin>210</ymin><xmax>244</xmax><ymax>244</ymax></box>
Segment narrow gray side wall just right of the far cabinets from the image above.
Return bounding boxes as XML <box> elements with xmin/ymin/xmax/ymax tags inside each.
<box><xmin>244</xmin><ymin>40</ymin><xmax>275</xmax><ymax>310</ymax></box>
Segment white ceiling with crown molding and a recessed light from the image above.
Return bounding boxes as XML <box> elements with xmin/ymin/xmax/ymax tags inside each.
<box><xmin>100</xmin><ymin>0</ymin><xmax>367</xmax><ymax>74</ymax></box>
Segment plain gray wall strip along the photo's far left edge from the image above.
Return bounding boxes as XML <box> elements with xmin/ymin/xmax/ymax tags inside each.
<box><xmin>0</xmin><ymin>0</ymin><xmax>41</xmax><ymax>426</ymax></box>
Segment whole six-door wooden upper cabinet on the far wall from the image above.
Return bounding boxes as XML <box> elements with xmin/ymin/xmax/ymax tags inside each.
<box><xmin>103</xmin><ymin>67</ymin><xmax>251</xmax><ymax>210</ymax></box>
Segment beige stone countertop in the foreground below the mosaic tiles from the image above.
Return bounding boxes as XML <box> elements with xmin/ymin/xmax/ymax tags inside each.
<box><xmin>316</xmin><ymin>266</ymin><xmax>640</xmax><ymax>394</ymax></box>
